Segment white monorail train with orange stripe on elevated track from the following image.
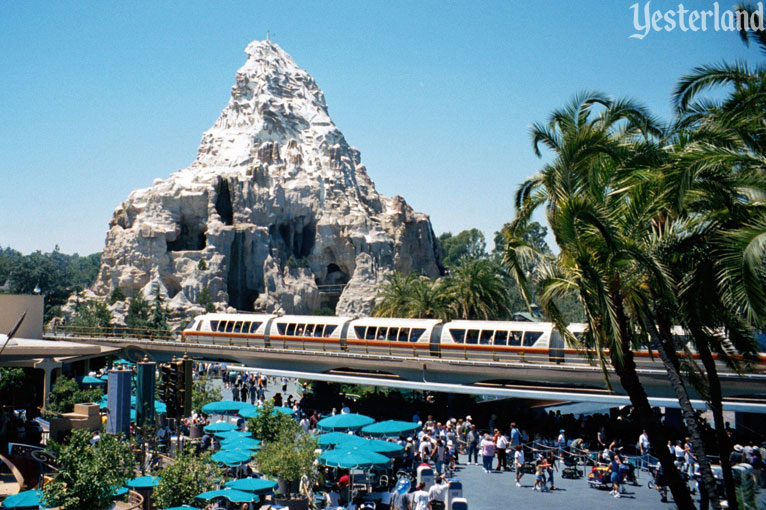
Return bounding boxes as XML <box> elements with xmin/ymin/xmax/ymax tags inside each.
<box><xmin>183</xmin><ymin>313</ymin><xmax>766</xmax><ymax>365</ymax></box>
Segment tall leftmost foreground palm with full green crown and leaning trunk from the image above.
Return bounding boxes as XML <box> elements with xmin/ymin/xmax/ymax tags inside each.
<box><xmin>504</xmin><ymin>94</ymin><xmax>704</xmax><ymax>509</ymax></box>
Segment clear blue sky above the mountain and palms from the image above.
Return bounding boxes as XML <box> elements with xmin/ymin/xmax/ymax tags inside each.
<box><xmin>0</xmin><ymin>0</ymin><xmax>762</xmax><ymax>254</ymax></box>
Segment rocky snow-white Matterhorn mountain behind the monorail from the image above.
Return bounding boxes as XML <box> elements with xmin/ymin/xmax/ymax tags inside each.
<box><xmin>91</xmin><ymin>41</ymin><xmax>439</xmax><ymax>316</ymax></box>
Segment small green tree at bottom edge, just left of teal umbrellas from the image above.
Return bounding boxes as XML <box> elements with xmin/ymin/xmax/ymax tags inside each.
<box><xmin>152</xmin><ymin>448</ymin><xmax>223</xmax><ymax>508</ymax></box>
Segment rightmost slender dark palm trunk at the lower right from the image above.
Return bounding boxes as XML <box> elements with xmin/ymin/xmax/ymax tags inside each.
<box><xmin>692</xmin><ymin>328</ymin><xmax>739</xmax><ymax>510</ymax></box>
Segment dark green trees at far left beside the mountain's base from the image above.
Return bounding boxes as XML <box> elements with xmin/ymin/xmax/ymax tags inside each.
<box><xmin>0</xmin><ymin>246</ymin><xmax>101</xmax><ymax>321</ymax></box>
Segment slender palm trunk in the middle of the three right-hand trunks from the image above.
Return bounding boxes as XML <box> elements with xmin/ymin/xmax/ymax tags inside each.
<box><xmin>642</xmin><ymin>308</ymin><xmax>721</xmax><ymax>509</ymax></box>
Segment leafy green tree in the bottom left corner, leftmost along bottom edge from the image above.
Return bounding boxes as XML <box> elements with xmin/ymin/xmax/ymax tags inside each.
<box><xmin>43</xmin><ymin>430</ymin><xmax>135</xmax><ymax>510</ymax></box>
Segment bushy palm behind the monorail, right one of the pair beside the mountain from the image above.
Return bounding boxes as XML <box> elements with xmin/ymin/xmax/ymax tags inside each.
<box><xmin>443</xmin><ymin>256</ymin><xmax>511</xmax><ymax>320</ymax></box>
